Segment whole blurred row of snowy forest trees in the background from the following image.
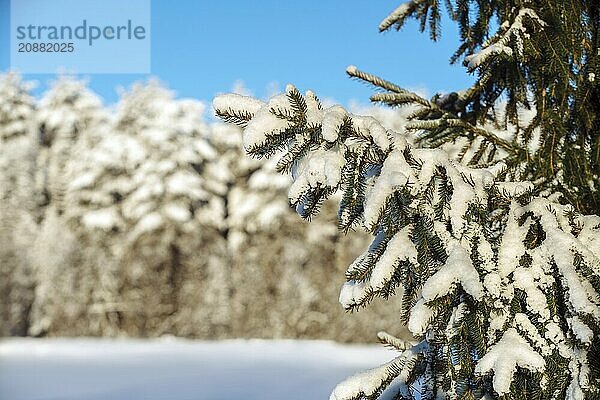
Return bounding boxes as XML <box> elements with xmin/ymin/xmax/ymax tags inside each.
<box><xmin>0</xmin><ymin>74</ymin><xmax>412</xmax><ymax>341</ymax></box>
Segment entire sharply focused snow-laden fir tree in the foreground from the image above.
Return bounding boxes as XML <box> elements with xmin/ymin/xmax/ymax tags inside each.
<box><xmin>213</xmin><ymin>0</ymin><xmax>600</xmax><ymax>400</ymax></box>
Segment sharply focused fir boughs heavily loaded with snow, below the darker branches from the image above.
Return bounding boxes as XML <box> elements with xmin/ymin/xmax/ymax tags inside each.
<box><xmin>213</xmin><ymin>85</ymin><xmax>600</xmax><ymax>399</ymax></box>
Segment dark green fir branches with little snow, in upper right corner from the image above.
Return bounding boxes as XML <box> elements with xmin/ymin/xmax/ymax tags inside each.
<box><xmin>370</xmin><ymin>0</ymin><xmax>600</xmax><ymax>214</ymax></box>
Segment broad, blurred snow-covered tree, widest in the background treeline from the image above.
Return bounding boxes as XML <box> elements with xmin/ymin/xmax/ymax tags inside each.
<box><xmin>65</xmin><ymin>82</ymin><xmax>227</xmax><ymax>336</ymax></box>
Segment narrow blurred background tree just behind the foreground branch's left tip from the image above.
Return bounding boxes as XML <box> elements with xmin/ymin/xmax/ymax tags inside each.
<box><xmin>207</xmin><ymin>123</ymin><xmax>301</xmax><ymax>337</ymax></box>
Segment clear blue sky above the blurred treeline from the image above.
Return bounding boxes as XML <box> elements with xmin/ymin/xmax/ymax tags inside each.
<box><xmin>0</xmin><ymin>0</ymin><xmax>473</xmax><ymax>104</ymax></box>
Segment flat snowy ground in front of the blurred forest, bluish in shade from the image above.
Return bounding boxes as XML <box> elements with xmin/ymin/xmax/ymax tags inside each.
<box><xmin>0</xmin><ymin>339</ymin><xmax>394</xmax><ymax>400</ymax></box>
